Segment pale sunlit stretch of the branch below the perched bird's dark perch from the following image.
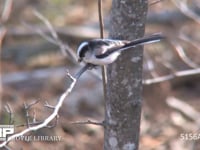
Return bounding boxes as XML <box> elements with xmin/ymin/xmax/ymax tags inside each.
<box><xmin>0</xmin><ymin>73</ymin><xmax>77</xmax><ymax>148</ymax></box>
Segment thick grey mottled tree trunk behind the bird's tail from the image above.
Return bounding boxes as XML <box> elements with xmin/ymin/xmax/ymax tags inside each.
<box><xmin>104</xmin><ymin>0</ymin><xmax>148</xmax><ymax>150</ymax></box>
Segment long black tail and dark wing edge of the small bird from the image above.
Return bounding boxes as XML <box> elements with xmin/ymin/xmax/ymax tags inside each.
<box><xmin>97</xmin><ymin>33</ymin><xmax>165</xmax><ymax>58</ymax></box>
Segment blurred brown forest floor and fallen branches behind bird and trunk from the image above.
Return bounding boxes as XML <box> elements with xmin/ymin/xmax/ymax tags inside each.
<box><xmin>0</xmin><ymin>0</ymin><xmax>200</xmax><ymax>150</ymax></box>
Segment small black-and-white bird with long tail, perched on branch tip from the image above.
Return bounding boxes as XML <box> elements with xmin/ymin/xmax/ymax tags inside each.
<box><xmin>77</xmin><ymin>34</ymin><xmax>164</xmax><ymax>65</ymax></box>
